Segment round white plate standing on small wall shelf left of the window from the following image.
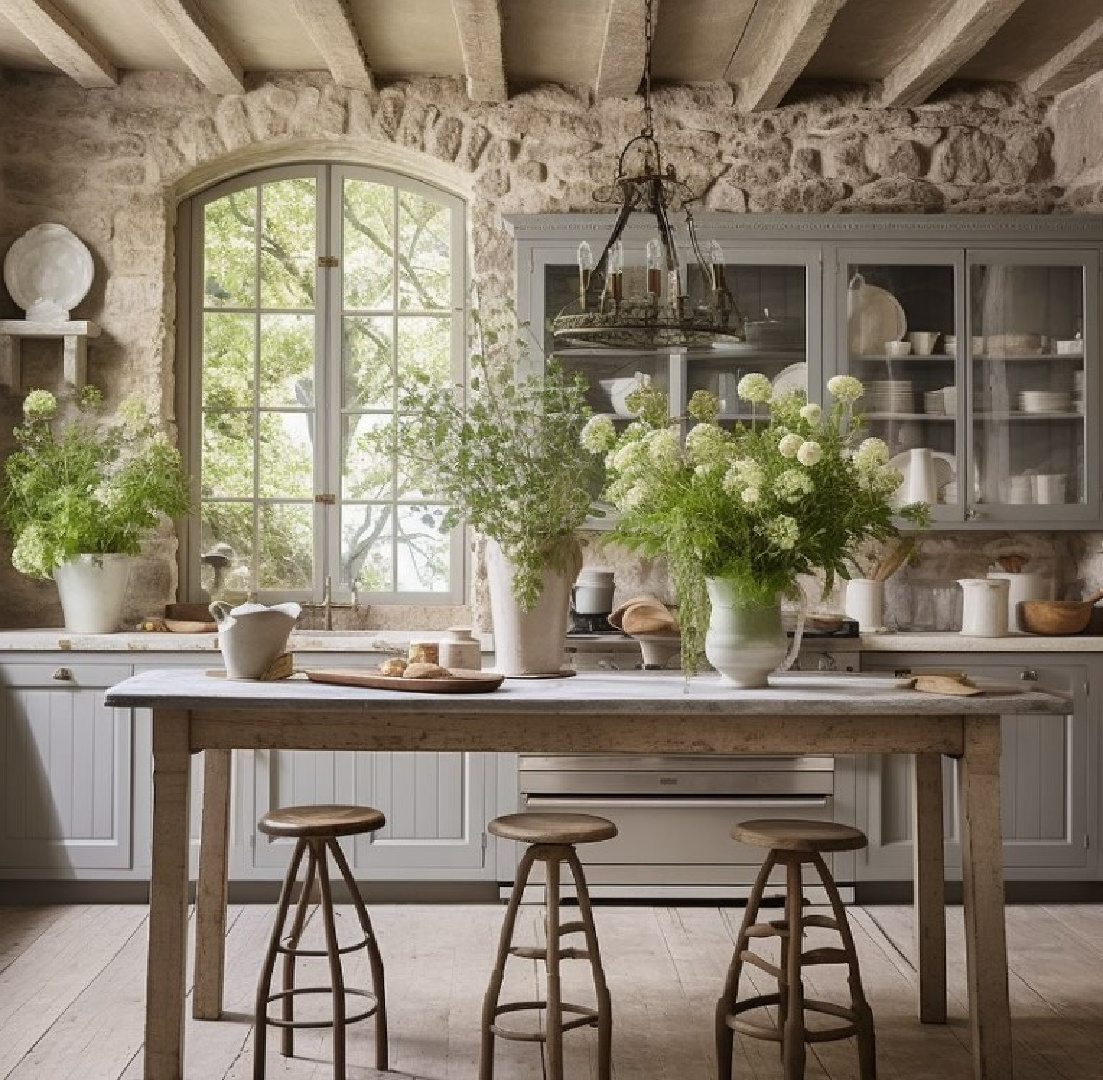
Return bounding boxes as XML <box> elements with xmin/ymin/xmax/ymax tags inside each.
<box><xmin>3</xmin><ymin>224</ymin><xmax>95</xmax><ymax>322</ymax></box>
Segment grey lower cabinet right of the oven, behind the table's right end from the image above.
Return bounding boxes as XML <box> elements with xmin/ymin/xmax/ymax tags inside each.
<box><xmin>856</xmin><ymin>653</ymin><xmax>1099</xmax><ymax>880</ymax></box>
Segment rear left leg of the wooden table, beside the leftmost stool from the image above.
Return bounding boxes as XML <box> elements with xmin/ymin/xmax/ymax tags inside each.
<box><xmin>192</xmin><ymin>750</ymin><xmax>232</xmax><ymax>1020</ymax></box>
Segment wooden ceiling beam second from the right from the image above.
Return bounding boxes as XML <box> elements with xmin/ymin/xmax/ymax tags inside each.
<box><xmin>881</xmin><ymin>0</ymin><xmax>1024</xmax><ymax>108</ymax></box>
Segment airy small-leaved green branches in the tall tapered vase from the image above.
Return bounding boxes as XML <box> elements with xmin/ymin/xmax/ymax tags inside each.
<box><xmin>397</xmin><ymin>323</ymin><xmax>598</xmax><ymax>610</ymax></box>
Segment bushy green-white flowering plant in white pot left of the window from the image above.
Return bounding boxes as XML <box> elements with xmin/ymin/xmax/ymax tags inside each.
<box><xmin>2</xmin><ymin>386</ymin><xmax>190</xmax><ymax>633</ymax></box>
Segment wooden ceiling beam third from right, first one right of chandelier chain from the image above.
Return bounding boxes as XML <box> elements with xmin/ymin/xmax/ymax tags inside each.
<box><xmin>728</xmin><ymin>0</ymin><xmax>846</xmax><ymax>113</ymax></box>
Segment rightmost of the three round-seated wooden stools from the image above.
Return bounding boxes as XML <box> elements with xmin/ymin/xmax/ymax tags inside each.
<box><xmin>716</xmin><ymin>820</ymin><xmax>877</xmax><ymax>1080</ymax></box>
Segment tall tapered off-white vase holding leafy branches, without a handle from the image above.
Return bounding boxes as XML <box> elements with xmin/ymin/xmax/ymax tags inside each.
<box><xmin>486</xmin><ymin>539</ymin><xmax>582</xmax><ymax>676</ymax></box>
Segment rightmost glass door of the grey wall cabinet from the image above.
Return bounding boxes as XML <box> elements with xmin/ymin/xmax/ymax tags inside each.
<box><xmin>968</xmin><ymin>252</ymin><xmax>1099</xmax><ymax>521</ymax></box>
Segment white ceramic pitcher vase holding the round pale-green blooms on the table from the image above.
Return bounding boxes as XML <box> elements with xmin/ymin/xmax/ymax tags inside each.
<box><xmin>705</xmin><ymin>578</ymin><xmax>789</xmax><ymax>689</ymax></box>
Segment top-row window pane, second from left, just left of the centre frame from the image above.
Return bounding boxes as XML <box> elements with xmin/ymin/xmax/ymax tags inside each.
<box><xmin>260</xmin><ymin>177</ymin><xmax>318</xmax><ymax>308</ymax></box>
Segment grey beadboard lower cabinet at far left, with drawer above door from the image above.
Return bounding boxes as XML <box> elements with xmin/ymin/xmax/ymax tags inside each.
<box><xmin>0</xmin><ymin>656</ymin><xmax>135</xmax><ymax>878</ymax></box>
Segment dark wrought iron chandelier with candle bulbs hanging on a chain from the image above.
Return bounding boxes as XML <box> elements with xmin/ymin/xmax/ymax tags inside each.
<box><xmin>552</xmin><ymin>0</ymin><xmax>743</xmax><ymax>349</ymax></box>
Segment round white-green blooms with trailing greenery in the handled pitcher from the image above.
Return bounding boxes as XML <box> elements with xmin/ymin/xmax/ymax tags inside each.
<box><xmin>582</xmin><ymin>373</ymin><xmax>928</xmax><ymax>671</ymax></box>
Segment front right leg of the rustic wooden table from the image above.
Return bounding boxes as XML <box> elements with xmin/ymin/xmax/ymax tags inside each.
<box><xmin>960</xmin><ymin>716</ymin><xmax>1014</xmax><ymax>1080</ymax></box>
